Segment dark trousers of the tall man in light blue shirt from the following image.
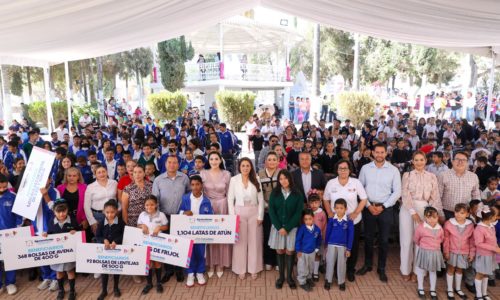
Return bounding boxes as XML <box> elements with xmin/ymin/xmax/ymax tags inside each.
<box><xmin>363</xmin><ymin>207</ymin><xmax>394</xmax><ymax>271</ymax></box>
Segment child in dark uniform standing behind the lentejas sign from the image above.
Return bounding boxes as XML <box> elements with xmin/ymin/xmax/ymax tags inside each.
<box><xmin>95</xmin><ymin>199</ymin><xmax>125</xmax><ymax>300</ymax></box>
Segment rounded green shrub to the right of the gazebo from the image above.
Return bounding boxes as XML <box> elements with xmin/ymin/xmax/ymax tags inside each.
<box><xmin>336</xmin><ymin>92</ymin><xmax>375</xmax><ymax>128</ymax></box>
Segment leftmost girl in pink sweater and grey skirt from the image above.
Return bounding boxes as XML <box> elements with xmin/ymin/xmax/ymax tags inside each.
<box><xmin>413</xmin><ymin>206</ymin><xmax>445</xmax><ymax>300</ymax></box>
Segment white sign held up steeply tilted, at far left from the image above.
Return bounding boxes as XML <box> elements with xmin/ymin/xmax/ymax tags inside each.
<box><xmin>12</xmin><ymin>147</ymin><xmax>56</xmax><ymax>221</ymax></box>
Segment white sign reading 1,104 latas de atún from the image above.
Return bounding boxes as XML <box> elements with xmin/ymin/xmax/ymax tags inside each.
<box><xmin>170</xmin><ymin>215</ymin><xmax>240</xmax><ymax>244</ymax></box>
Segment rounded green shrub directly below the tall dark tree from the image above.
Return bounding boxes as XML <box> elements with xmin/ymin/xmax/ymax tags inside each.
<box><xmin>148</xmin><ymin>91</ymin><xmax>187</xmax><ymax>120</ymax></box>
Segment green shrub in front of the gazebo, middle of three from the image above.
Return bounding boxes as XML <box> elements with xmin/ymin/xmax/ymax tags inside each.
<box><xmin>215</xmin><ymin>90</ymin><xmax>256</xmax><ymax>132</ymax></box>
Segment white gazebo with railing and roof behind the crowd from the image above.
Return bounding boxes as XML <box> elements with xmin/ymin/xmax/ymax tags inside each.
<box><xmin>184</xmin><ymin>16</ymin><xmax>302</xmax><ymax>117</ymax></box>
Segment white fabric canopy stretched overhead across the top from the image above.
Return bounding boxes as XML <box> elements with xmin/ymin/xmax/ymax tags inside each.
<box><xmin>0</xmin><ymin>0</ymin><xmax>500</xmax><ymax>127</ymax></box>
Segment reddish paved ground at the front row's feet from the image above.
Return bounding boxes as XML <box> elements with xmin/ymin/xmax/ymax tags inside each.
<box><xmin>10</xmin><ymin>247</ymin><xmax>500</xmax><ymax>300</ymax></box>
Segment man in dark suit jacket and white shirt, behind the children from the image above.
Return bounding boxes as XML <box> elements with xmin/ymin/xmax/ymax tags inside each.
<box><xmin>292</xmin><ymin>152</ymin><xmax>326</xmax><ymax>202</ymax></box>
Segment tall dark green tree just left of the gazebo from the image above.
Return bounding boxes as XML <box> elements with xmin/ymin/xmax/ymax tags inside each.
<box><xmin>158</xmin><ymin>36</ymin><xmax>194</xmax><ymax>91</ymax></box>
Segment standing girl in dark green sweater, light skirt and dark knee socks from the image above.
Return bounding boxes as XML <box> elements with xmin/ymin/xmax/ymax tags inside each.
<box><xmin>269</xmin><ymin>170</ymin><xmax>304</xmax><ymax>289</ymax></box>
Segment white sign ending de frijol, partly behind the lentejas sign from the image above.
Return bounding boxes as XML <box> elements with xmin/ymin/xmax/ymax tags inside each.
<box><xmin>123</xmin><ymin>226</ymin><xmax>193</xmax><ymax>268</ymax></box>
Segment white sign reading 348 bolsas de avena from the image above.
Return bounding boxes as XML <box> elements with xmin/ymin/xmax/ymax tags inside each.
<box><xmin>2</xmin><ymin>231</ymin><xmax>85</xmax><ymax>271</ymax></box>
